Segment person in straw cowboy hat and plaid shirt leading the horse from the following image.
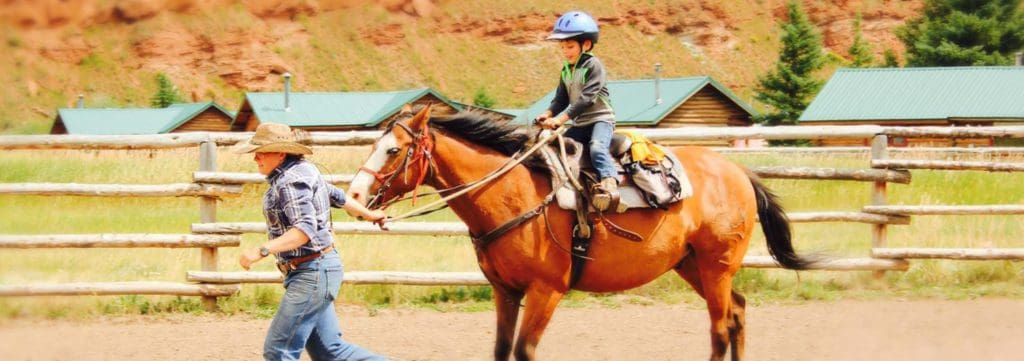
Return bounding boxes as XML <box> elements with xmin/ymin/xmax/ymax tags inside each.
<box><xmin>232</xmin><ymin>123</ymin><xmax>386</xmax><ymax>361</ymax></box>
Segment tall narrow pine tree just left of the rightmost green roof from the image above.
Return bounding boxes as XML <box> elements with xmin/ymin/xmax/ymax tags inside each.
<box><xmin>755</xmin><ymin>1</ymin><xmax>824</xmax><ymax>131</ymax></box>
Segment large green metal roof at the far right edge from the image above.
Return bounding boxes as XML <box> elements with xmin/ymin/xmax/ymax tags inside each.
<box><xmin>800</xmin><ymin>66</ymin><xmax>1024</xmax><ymax>123</ymax></box>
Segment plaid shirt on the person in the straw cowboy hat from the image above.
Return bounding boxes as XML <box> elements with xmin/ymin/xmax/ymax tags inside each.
<box><xmin>263</xmin><ymin>159</ymin><xmax>345</xmax><ymax>260</ymax></box>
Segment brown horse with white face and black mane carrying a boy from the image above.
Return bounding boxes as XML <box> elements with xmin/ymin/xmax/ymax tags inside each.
<box><xmin>348</xmin><ymin>107</ymin><xmax>816</xmax><ymax>361</ymax></box>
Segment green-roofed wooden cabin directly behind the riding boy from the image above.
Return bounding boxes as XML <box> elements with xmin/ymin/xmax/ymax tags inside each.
<box><xmin>514</xmin><ymin>77</ymin><xmax>757</xmax><ymax>146</ymax></box>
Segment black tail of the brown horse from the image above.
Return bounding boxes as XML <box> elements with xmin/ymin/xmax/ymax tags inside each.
<box><xmin>750</xmin><ymin>174</ymin><xmax>815</xmax><ymax>270</ymax></box>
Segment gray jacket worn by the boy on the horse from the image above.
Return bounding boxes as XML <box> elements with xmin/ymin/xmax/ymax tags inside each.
<box><xmin>548</xmin><ymin>53</ymin><xmax>615</xmax><ymax>127</ymax></box>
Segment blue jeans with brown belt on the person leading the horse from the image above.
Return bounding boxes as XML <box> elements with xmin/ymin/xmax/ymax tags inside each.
<box><xmin>263</xmin><ymin>250</ymin><xmax>387</xmax><ymax>361</ymax></box>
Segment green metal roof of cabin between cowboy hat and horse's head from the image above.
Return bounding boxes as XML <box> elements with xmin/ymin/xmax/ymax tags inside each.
<box><xmin>246</xmin><ymin>88</ymin><xmax>462</xmax><ymax>127</ymax></box>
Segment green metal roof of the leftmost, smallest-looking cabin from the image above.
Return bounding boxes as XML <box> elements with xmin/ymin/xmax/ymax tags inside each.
<box><xmin>57</xmin><ymin>101</ymin><xmax>234</xmax><ymax>135</ymax></box>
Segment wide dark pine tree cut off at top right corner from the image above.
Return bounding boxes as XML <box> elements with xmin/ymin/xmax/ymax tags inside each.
<box><xmin>896</xmin><ymin>0</ymin><xmax>1024</xmax><ymax>66</ymax></box>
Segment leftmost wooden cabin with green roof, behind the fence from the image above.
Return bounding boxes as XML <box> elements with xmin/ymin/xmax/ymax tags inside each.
<box><xmin>50</xmin><ymin>101</ymin><xmax>234</xmax><ymax>135</ymax></box>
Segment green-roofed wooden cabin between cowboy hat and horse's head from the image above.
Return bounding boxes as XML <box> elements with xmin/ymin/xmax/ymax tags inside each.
<box><xmin>231</xmin><ymin>88</ymin><xmax>462</xmax><ymax>131</ymax></box>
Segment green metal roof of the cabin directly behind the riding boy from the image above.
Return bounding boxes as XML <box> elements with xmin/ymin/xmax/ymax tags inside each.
<box><xmin>513</xmin><ymin>77</ymin><xmax>758</xmax><ymax>126</ymax></box>
